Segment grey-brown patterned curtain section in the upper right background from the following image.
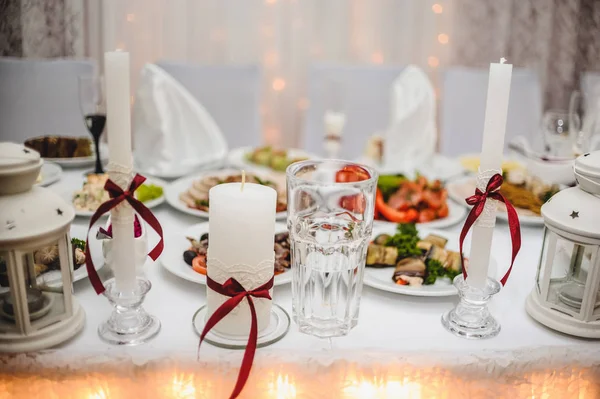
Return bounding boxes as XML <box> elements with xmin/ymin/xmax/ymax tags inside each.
<box><xmin>450</xmin><ymin>0</ymin><xmax>600</xmax><ymax>109</ymax></box>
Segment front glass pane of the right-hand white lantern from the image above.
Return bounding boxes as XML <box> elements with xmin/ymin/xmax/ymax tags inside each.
<box><xmin>546</xmin><ymin>236</ymin><xmax>597</xmax><ymax>316</ymax></box>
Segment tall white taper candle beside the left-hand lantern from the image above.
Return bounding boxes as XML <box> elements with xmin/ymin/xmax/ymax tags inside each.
<box><xmin>104</xmin><ymin>51</ymin><xmax>136</xmax><ymax>292</ymax></box>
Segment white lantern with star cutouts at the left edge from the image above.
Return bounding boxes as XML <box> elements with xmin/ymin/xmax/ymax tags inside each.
<box><xmin>0</xmin><ymin>143</ymin><xmax>85</xmax><ymax>352</ymax></box>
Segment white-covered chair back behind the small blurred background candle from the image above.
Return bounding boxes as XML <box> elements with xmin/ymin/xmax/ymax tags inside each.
<box><xmin>302</xmin><ymin>64</ymin><xmax>404</xmax><ymax>160</ymax></box>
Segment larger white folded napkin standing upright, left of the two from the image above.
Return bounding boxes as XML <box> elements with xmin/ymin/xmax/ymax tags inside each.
<box><xmin>133</xmin><ymin>64</ymin><xmax>228</xmax><ymax>178</ymax></box>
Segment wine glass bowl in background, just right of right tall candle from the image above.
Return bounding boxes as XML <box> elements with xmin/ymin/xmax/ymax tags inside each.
<box><xmin>542</xmin><ymin>110</ymin><xmax>581</xmax><ymax>156</ymax></box>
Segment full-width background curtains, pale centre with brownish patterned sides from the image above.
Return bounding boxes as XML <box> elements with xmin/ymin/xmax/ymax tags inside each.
<box><xmin>0</xmin><ymin>0</ymin><xmax>600</xmax><ymax>146</ymax></box>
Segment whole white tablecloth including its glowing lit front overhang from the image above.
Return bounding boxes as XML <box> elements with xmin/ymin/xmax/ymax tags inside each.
<box><xmin>0</xmin><ymin>169</ymin><xmax>600</xmax><ymax>398</ymax></box>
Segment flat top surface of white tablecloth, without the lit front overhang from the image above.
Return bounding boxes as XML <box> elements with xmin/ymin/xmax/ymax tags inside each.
<box><xmin>42</xmin><ymin>169</ymin><xmax>592</xmax><ymax>358</ymax></box>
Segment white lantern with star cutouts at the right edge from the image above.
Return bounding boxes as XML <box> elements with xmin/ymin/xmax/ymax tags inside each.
<box><xmin>526</xmin><ymin>151</ymin><xmax>600</xmax><ymax>338</ymax></box>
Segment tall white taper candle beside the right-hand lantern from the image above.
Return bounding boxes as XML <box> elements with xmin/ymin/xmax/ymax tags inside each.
<box><xmin>467</xmin><ymin>58</ymin><xmax>512</xmax><ymax>288</ymax></box>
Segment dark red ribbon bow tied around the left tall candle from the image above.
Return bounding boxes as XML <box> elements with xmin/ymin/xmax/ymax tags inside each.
<box><xmin>85</xmin><ymin>174</ymin><xmax>165</xmax><ymax>295</ymax></box>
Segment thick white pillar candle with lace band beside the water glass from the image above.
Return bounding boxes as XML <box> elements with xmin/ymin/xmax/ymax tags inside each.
<box><xmin>206</xmin><ymin>183</ymin><xmax>277</xmax><ymax>335</ymax></box>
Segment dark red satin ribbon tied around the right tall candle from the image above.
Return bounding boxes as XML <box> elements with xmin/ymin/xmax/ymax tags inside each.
<box><xmin>460</xmin><ymin>173</ymin><xmax>521</xmax><ymax>285</ymax></box>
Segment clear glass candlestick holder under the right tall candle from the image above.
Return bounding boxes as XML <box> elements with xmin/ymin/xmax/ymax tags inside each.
<box><xmin>442</xmin><ymin>274</ymin><xmax>502</xmax><ymax>339</ymax></box>
